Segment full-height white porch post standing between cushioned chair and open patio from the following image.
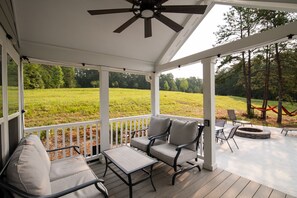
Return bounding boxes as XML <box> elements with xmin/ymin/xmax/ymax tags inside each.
<box><xmin>201</xmin><ymin>58</ymin><xmax>217</xmax><ymax>170</ymax></box>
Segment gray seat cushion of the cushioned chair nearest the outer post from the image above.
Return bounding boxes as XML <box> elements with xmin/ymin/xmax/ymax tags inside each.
<box><xmin>150</xmin><ymin>143</ymin><xmax>197</xmax><ymax>166</ymax></box>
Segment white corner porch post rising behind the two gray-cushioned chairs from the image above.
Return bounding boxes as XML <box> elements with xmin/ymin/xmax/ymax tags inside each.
<box><xmin>151</xmin><ymin>73</ymin><xmax>160</xmax><ymax>115</ymax></box>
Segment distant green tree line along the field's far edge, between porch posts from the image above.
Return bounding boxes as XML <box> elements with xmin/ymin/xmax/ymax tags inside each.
<box><xmin>23</xmin><ymin>63</ymin><xmax>202</xmax><ymax>93</ymax></box>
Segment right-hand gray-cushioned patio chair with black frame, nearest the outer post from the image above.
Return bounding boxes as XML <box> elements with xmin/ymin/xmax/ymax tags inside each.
<box><xmin>150</xmin><ymin>120</ymin><xmax>203</xmax><ymax>185</ymax></box>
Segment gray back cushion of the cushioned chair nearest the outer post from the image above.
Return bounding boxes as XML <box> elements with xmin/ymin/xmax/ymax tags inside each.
<box><xmin>169</xmin><ymin>120</ymin><xmax>198</xmax><ymax>151</ymax></box>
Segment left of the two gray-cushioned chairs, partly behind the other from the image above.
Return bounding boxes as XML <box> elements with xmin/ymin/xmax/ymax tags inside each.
<box><xmin>130</xmin><ymin>116</ymin><xmax>171</xmax><ymax>154</ymax></box>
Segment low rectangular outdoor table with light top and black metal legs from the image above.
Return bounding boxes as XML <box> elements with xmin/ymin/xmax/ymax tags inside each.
<box><xmin>102</xmin><ymin>146</ymin><xmax>158</xmax><ymax>198</ymax></box>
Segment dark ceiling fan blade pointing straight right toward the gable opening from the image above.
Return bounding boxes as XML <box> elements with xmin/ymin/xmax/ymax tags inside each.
<box><xmin>160</xmin><ymin>5</ymin><xmax>207</xmax><ymax>14</ymax></box>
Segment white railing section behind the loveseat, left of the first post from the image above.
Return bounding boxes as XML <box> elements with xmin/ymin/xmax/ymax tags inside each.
<box><xmin>24</xmin><ymin>120</ymin><xmax>100</xmax><ymax>160</ymax></box>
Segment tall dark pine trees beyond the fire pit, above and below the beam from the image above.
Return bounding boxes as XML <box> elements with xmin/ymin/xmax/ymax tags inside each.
<box><xmin>215</xmin><ymin>7</ymin><xmax>297</xmax><ymax>124</ymax></box>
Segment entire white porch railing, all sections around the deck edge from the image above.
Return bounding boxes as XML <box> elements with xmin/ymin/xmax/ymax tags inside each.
<box><xmin>24</xmin><ymin>115</ymin><xmax>204</xmax><ymax>160</ymax></box>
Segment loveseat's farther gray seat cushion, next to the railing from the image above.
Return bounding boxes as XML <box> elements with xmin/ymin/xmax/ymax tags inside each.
<box><xmin>49</xmin><ymin>155</ymin><xmax>90</xmax><ymax>182</ymax></box>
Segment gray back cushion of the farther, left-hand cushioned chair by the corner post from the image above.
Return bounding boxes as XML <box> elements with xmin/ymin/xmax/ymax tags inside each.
<box><xmin>148</xmin><ymin>116</ymin><xmax>170</xmax><ymax>137</ymax></box>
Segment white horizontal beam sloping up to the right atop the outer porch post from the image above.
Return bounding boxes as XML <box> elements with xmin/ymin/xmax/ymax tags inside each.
<box><xmin>156</xmin><ymin>21</ymin><xmax>297</xmax><ymax>72</ymax></box>
